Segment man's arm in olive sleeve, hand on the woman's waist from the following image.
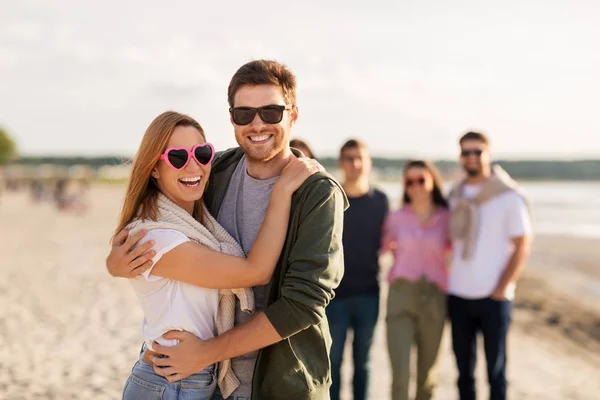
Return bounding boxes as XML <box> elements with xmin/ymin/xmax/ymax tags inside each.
<box><xmin>152</xmin><ymin>180</ymin><xmax>344</xmax><ymax>382</ymax></box>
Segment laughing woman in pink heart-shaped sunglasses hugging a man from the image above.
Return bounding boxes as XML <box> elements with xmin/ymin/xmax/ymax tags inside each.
<box><xmin>116</xmin><ymin>111</ymin><xmax>322</xmax><ymax>400</ymax></box>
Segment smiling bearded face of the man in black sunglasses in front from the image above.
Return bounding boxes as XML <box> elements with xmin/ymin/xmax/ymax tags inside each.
<box><xmin>231</xmin><ymin>85</ymin><xmax>298</xmax><ymax>162</ymax></box>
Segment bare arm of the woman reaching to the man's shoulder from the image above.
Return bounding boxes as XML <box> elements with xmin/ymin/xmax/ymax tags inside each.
<box><xmin>152</xmin><ymin>158</ymin><xmax>323</xmax><ymax>289</ymax></box>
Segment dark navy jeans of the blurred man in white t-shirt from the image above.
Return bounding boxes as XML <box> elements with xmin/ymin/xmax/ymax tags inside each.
<box><xmin>448</xmin><ymin>296</ymin><xmax>512</xmax><ymax>400</ymax></box>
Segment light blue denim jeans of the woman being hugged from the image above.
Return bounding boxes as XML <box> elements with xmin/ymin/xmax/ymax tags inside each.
<box><xmin>123</xmin><ymin>352</ymin><xmax>217</xmax><ymax>400</ymax></box>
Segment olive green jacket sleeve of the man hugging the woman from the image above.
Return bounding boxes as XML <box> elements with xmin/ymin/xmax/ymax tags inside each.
<box><xmin>265</xmin><ymin>179</ymin><xmax>346</xmax><ymax>339</ymax></box>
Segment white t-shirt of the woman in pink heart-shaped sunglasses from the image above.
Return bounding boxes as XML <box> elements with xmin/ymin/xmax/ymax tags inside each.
<box><xmin>129</xmin><ymin>229</ymin><xmax>219</xmax><ymax>350</ymax></box>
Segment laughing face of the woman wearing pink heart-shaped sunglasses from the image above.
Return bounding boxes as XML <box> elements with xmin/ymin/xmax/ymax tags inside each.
<box><xmin>152</xmin><ymin>126</ymin><xmax>211</xmax><ymax>214</ymax></box>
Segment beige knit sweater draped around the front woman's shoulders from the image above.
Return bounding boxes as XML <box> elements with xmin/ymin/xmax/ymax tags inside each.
<box><xmin>129</xmin><ymin>194</ymin><xmax>254</xmax><ymax>398</ymax></box>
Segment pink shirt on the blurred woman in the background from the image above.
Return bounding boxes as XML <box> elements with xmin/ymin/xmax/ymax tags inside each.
<box><xmin>382</xmin><ymin>206</ymin><xmax>450</xmax><ymax>292</ymax></box>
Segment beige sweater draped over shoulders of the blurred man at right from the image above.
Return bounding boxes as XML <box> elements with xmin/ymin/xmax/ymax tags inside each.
<box><xmin>450</xmin><ymin>165</ymin><xmax>531</xmax><ymax>260</ymax></box>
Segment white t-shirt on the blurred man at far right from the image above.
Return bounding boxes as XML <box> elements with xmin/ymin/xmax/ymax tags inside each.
<box><xmin>448</xmin><ymin>185</ymin><xmax>531</xmax><ymax>300</ymax></box>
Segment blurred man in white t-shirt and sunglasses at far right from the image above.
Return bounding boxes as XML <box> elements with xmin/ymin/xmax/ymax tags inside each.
<box><xmin>448</xmin><ymin>132</ymin><xmax>531</xmax><ymax>400</ymax></box>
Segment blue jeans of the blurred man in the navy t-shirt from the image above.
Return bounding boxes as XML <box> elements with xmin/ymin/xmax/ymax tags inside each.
<box><xmin>325</xmin><ymin>293</ymin><xmax>379</xmax><ymax>400</ymax></box>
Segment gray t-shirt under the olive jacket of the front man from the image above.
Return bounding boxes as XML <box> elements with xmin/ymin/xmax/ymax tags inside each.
<box><xmin>216</xmin><ymin>156</ymin><xmax>279</xmax><ymax>400</ymax></box>
